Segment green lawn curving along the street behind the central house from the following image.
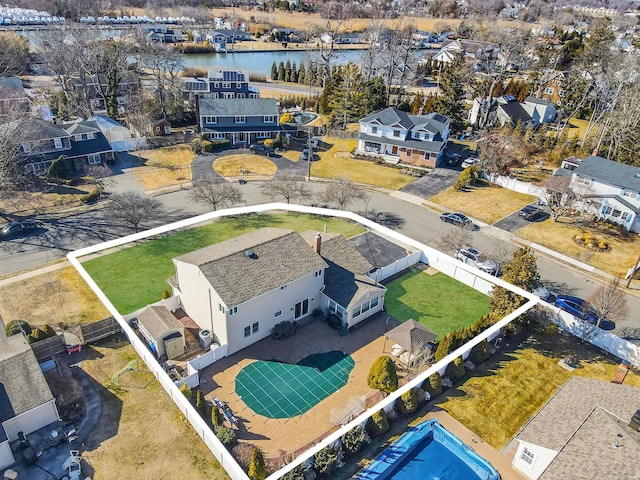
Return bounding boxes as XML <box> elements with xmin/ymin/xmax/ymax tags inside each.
<box><xmin>83</xmin><ymin>213</ymin><xmax>364</xmax><ymax>314</ymax></box>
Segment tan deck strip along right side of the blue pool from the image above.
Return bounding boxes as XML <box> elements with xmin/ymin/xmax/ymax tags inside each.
<box><xmin>423</xmin><ymin>407</ymin><xmax>528</xmax><ymax>480</ymax></box>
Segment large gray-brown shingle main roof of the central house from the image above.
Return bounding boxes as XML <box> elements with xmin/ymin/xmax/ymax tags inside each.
<box><xmin>176</xmin><ymin>227</ymin><xmax>327</xmax><ymax>307</ymax></box>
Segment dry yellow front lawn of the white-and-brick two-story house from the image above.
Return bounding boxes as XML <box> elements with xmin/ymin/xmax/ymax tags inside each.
<box><xmin>311</xmin><ymin>137</ymin><xmax>415</xmax><ymax>190</ymax></box>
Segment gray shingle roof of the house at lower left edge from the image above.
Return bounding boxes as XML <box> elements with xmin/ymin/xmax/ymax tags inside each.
<box><xmin>0</xmin><ymin>334</ymin><xmax>53</xmax><ymax>441</ymax></box>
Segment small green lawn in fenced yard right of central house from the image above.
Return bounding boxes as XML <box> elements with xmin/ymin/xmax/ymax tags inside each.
<box><xmin>384</xmin><ymin>269</ymin><xmax>489</xmax><ymax>339</ymax></box>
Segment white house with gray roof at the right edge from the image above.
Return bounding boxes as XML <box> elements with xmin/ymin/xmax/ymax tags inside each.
<box><xmin>560</xmin><ymin>155</ymin><xmax>640</xmax><ymax>233</ymax></box>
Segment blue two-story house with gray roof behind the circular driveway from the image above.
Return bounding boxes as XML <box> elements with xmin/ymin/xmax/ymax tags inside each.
<box><xmin>195</xmin><ymin>96</ymin><xmax>280</xmax><ymax>145</ymax></box>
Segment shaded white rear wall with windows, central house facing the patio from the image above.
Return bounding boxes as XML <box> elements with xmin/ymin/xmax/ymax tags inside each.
<box><xmin>227</xmin><ymin>272</ymin><xmax>324</xmax><ymax>355</ymax></box>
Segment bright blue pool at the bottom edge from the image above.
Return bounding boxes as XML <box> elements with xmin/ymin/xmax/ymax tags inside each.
<box><xmin>356</xmin><ymin>419</ymin><xmax>500</xmax><ymax>480</ymax></box>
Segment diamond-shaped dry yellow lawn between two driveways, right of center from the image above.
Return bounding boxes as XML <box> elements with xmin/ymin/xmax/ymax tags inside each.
<box><xmin>429</xmin><ymin>186</ymin><xmax>535</xmax><ymax>224</ymax></box>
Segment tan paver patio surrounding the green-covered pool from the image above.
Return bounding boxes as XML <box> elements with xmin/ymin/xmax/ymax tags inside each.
<box><xmin>200</xmin><ymin>312</ymin><xmax>398</xmax><ymax>457</ymax></box>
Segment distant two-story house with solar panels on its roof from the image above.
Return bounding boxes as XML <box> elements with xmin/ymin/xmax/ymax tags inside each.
<box><xmin>182</xmin><ymin>67</ymin><xmax>260</xmax><ymax>100</ymax></box>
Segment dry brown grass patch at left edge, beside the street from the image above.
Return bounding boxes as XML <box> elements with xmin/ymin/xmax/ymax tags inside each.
<box><xmin>0</xmin><ymin>267</ymin><xmax>109</xmax><ymax>326</ymax></box>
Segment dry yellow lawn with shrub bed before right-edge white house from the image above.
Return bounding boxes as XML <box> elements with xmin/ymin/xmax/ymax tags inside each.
<box><xmin>516</xmin><ymin>218</ymin><xmax>640</xmax><ymax>276</ymax></box>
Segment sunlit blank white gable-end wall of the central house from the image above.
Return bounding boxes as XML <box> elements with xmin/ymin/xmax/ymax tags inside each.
<box><xmin>174</xmin><ymin>261</ymin><xmax>228</xmax><ymax>345</ymax></box>
